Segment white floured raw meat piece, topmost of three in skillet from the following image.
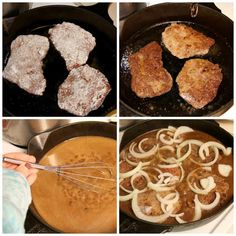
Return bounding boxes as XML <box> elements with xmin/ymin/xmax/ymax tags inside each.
<box><xmin>49</xmin><ymin>22</ymin><xmax>96</xmax><ymax>71</ymax></box>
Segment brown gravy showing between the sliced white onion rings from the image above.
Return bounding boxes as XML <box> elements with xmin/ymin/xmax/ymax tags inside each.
<box><xmin>120</xmin><ymin>130</ymin><xmax>233</xmax><ymax>224</ymax></box>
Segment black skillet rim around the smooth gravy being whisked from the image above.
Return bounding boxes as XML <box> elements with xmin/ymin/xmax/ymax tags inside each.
<box><xmin>28</xmin><ymin>122</ymin><xmax>116</xmax><ymax>232</ymax></box>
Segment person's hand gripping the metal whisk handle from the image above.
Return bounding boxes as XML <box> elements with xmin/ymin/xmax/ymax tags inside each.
<box><xmin>3</xmin><ymin>152</ymin><xmax>38</xmax><ymax>185</ymax></box>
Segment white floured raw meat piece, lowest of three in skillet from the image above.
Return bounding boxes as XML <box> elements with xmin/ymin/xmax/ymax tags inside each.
<box><xmin>58</xmin><ymin>65</ymin><xmax>111</xmax><ymax>116</ymax></box>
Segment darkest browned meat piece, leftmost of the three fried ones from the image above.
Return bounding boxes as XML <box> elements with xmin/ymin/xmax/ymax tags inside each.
<box><xmin>129</xmin><ymin>42</ymin><xmax>173</xmax><ymax>98</ymax></box>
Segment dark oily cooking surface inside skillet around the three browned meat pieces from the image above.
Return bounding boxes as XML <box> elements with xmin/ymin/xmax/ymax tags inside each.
<box><xmin>120</xmin><ymin>3</ymin><xmax>233</xmax><ymax>116</ymax></box>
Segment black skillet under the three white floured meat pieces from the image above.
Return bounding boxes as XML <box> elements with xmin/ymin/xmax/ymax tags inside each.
<box><xmin>3</xmin><ymin>6</ymin><xmax>116</xmax><ymax>116</ymax></box>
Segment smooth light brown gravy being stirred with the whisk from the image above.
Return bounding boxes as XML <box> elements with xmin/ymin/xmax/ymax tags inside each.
<box><xmin>32</xmin><ymin>136</ymin><xmax>116</xmax><ymax>233</ymax></box>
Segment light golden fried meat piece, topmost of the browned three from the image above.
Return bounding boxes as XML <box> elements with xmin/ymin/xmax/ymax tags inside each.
<box><xmin>162</xmin><ymin>23</ymin><xmax>215</xmax><ymax>59</ymax></box>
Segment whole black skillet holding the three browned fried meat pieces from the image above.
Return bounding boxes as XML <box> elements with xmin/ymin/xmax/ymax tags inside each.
<box><xmin>120</xmin><ymin>3</ymin><xmax>233</xmax><ymax>116</ymax></box>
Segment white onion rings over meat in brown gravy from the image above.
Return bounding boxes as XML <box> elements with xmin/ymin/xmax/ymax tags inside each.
<box><xmin>120</xmin><ymin>126</ymin><xmax>232</xmax><ymax>224</ymax></box>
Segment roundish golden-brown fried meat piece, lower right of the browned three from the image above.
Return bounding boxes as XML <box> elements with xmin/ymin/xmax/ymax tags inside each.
<box><xmin>176</xmin><ymin>59</ymin><xmax>223</xmax><ymax>109</ymax></box>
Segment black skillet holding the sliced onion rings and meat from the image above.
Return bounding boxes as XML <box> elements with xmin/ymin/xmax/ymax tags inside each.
<box><xmin>120</xmin><ymin>120</ymin><xmax>233</xmax><ymax>233</ymax></box>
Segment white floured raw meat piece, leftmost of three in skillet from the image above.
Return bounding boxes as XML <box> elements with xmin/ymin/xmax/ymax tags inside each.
<box><xmin>3</xmin><ymin>35</ymin><xmax>49</xmax><ymax>95</ymax></box>
